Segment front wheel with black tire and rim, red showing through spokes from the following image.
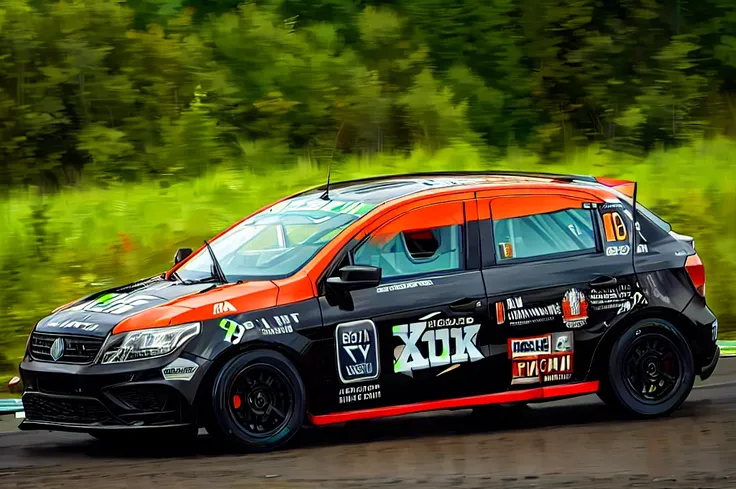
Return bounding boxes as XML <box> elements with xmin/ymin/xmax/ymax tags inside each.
<box><xmin>207</xmin><ymin>350</ymin><xmax>307</xmax><ymax>452</ymax></box>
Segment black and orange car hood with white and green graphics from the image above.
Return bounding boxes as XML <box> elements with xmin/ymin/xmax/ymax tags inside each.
<box><xmin>35</xmin><ymin>277</ymin><xmax>277</xmax><ymax>337</ymax></box>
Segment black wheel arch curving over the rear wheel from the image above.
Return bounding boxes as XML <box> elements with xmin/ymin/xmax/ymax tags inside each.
<box><xmin>586</xmin><ymin>307</ymin><xmax>699</xmax><ymax>380</ymax></box>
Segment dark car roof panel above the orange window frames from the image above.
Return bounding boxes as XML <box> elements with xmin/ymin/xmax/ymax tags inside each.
<box><xmin>307</xmin><ymin>171</ymin><xmax>598</xmax><ymax>204</ymax></box>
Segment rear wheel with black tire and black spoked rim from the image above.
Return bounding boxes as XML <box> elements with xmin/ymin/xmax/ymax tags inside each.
<box><xmin>599</xmin><ymin>319</ymin><xmax>695</xmax><ymax>418</ymax></box>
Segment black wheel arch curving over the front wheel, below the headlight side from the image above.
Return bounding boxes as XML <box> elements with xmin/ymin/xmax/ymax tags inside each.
<box><xmin>194</xmin><ymin>340</ymin><xmax>309</xmax><ymax>426</ymax></box>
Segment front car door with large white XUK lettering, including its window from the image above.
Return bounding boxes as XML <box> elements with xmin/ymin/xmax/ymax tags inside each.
<box><xmin>320</xmin><ymin>200</ymin><xmax>498</xmax><ymax>412</ymax></box>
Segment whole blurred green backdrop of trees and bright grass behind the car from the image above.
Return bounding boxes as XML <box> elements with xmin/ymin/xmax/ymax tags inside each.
<box><xmin>0</xmin><ymin>0</ymin><xmax>736</xmax><ymax>388</ymax></box>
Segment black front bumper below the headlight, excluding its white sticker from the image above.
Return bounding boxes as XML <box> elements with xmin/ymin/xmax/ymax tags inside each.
<box><xmin>20</xmin><ymin>354</ymin><xmax>210</xmax><ymax>432</ymax></box>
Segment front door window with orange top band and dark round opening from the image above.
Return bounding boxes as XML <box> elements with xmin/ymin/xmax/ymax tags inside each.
<box><xmin>353</xmin><ymin>202</ymin><xmax>465</xmax><ymax>279</ymax></box>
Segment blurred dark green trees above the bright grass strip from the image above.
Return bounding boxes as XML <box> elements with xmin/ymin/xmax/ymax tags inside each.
<box><xmin>0</xmin><ymin>0</ymin><xmax>736</xmax><ymax>187</ymax></box>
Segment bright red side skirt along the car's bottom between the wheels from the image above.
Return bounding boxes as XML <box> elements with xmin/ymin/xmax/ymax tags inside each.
<box><xmin>309</xmin><ymin>380</ymin><xmax>598</xmax><ymax>426</ymax></box>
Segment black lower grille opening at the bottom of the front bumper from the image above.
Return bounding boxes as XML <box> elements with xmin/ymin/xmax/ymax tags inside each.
<box><xmin>23</xmin><ymin>394</ymin><xmax>112</xmax><ymax>424</ymax></box>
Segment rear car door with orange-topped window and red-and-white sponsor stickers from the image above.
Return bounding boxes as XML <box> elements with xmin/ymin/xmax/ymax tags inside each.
<box><xmin>479</xmin><ymin>193</ymin><xmax>635</xmax><ymax>388</ymax></box>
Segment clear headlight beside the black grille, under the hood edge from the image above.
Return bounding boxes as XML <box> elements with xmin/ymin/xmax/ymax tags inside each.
<box><xmin>101</xmin><ymin>323</ymin><xmax>200</xmax><ymax>363</ymax></box>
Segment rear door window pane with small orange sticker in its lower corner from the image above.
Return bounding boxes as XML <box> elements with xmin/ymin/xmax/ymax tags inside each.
<box><xmin>493</xmin><ymin>209</ymin><xmax>596</xmax><ymax>263</ymax></box>
